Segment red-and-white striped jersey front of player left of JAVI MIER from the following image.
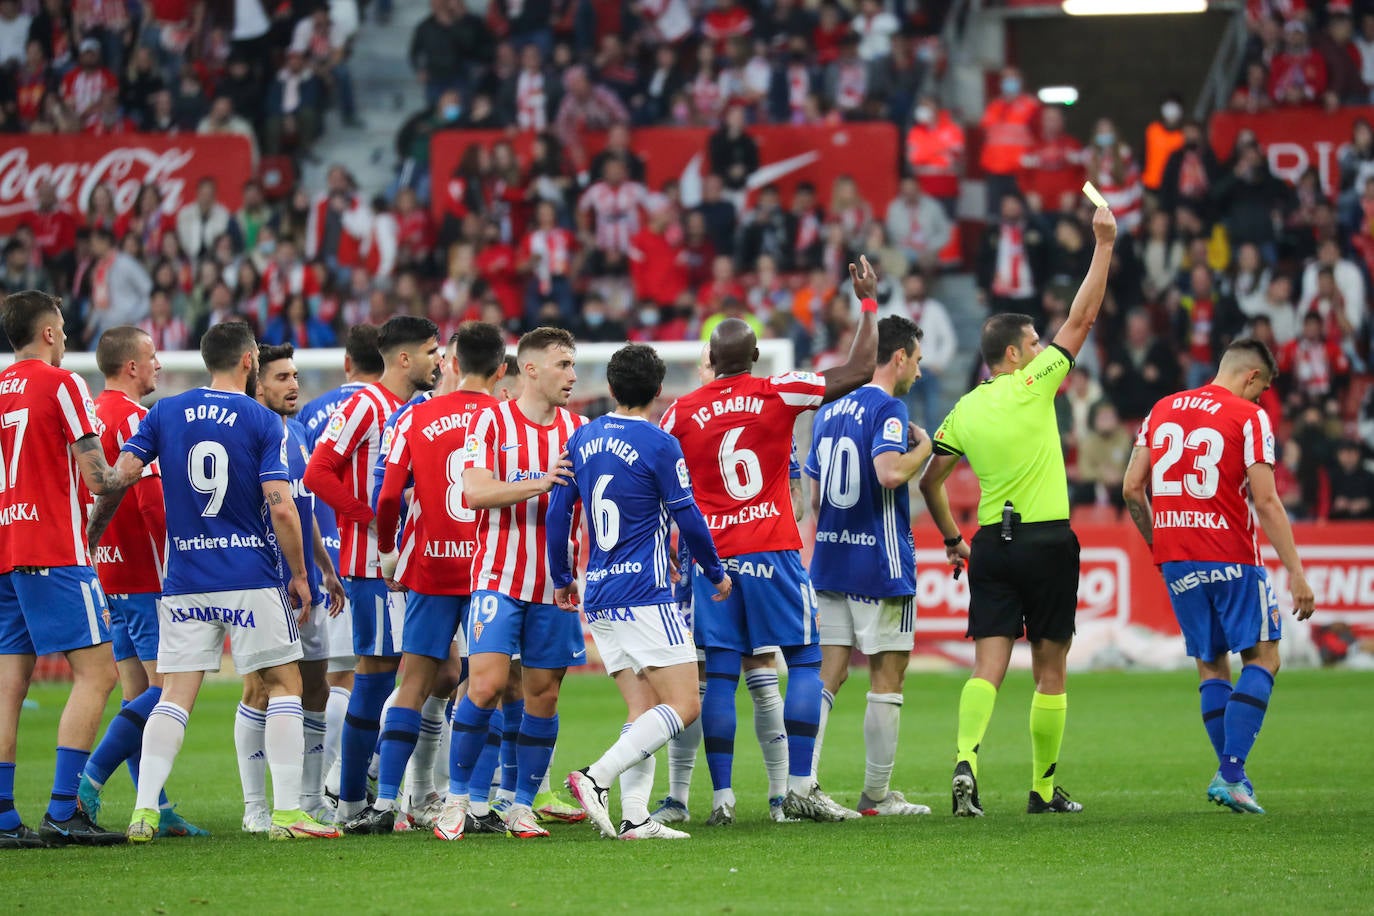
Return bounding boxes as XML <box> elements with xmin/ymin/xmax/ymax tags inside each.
<box><xmin>464</xmin><ymin>401</ymin><xmax>587</xmax><ymax>604</ymax></box>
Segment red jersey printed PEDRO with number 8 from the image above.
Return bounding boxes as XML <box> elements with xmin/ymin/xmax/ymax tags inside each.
<box><xmin>378</xmin><ymin>391</ymin><xmax>497</xmax><ymax>595</ymax></box>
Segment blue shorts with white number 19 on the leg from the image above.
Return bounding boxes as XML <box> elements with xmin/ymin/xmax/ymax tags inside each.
<box><xmin>467</xmin><ymin>591</ymin><xmax>587</xmax><ymax>669</ymax></box>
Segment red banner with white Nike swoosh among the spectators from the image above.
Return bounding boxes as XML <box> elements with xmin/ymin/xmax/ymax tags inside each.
<box><xmin>430</xmin><ymin>124</ymin><xmax>897</xmax><ymax>217</ymax></box>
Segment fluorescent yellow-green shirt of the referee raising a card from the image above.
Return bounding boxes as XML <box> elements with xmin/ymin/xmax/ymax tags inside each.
<box><xmin>934</xmin><ymin>343</ymin><xmax>1073</xmax><ymax>525</ymax></box>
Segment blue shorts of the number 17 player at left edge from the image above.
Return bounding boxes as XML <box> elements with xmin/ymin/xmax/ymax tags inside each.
<box><xmin>0</xmin><ymin>566</ymin><xmax>110</xmax><ymax>655</ymax></box>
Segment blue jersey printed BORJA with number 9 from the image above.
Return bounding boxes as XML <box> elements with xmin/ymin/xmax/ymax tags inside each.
<box><xmin>124</xmin><ymin>389</ymin><xmax>290</xmax><ymax>595</ymax></box>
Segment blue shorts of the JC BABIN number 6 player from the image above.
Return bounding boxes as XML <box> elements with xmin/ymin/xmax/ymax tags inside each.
<box><xmin>691</xmin><ymin>551</ymin><xmax>819</xmax><ymax>655</ymax></box>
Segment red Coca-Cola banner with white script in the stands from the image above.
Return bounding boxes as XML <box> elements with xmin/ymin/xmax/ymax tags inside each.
<box><xmin>0</xmin><ymin>133</ymin><xmax>253</xmax><ymax>235</ymax></box>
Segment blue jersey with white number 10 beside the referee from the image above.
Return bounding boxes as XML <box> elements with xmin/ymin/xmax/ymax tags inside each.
<box><xmin>807</xmin><ymin>385</ymin><xmax>916</xmax><ymax>597</ymax></box>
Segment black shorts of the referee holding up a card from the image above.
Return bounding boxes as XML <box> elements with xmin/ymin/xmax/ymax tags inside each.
<box><xmin>967</xmin><ymin>520</ymin><xmax>1079</xmax><ymax>643</ymax></box>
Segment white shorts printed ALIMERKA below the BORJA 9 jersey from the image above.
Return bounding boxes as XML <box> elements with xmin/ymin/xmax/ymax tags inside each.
<box><xmin>158</xmin><ymin>588</ymin><xmax>301</xmax><ymax>674</ymax></box>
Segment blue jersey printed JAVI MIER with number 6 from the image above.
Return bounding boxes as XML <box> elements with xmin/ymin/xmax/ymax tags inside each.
<box><xmin>548</xmin><ymin>413</ymin><xmax>723</xmax><ymax>611</ymax></box>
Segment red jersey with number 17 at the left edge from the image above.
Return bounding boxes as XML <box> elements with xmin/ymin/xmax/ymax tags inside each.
<box><xmin>0</xmin><ymin>360</ymin><xmax>100</xmax><ymax>573</ymax></box>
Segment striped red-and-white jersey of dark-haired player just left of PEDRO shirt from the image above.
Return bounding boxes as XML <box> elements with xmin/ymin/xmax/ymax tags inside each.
<box><xmin>306</xmin><ymin>383</ymin><xmax>405</xmax><ymax>578</ymax></box>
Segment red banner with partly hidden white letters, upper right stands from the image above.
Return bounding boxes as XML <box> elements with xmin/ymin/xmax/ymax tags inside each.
<box><xmin>1210</xmin><ymin>106</ymin><xmax>1374</xmax><ymax>195</ymax></box>
